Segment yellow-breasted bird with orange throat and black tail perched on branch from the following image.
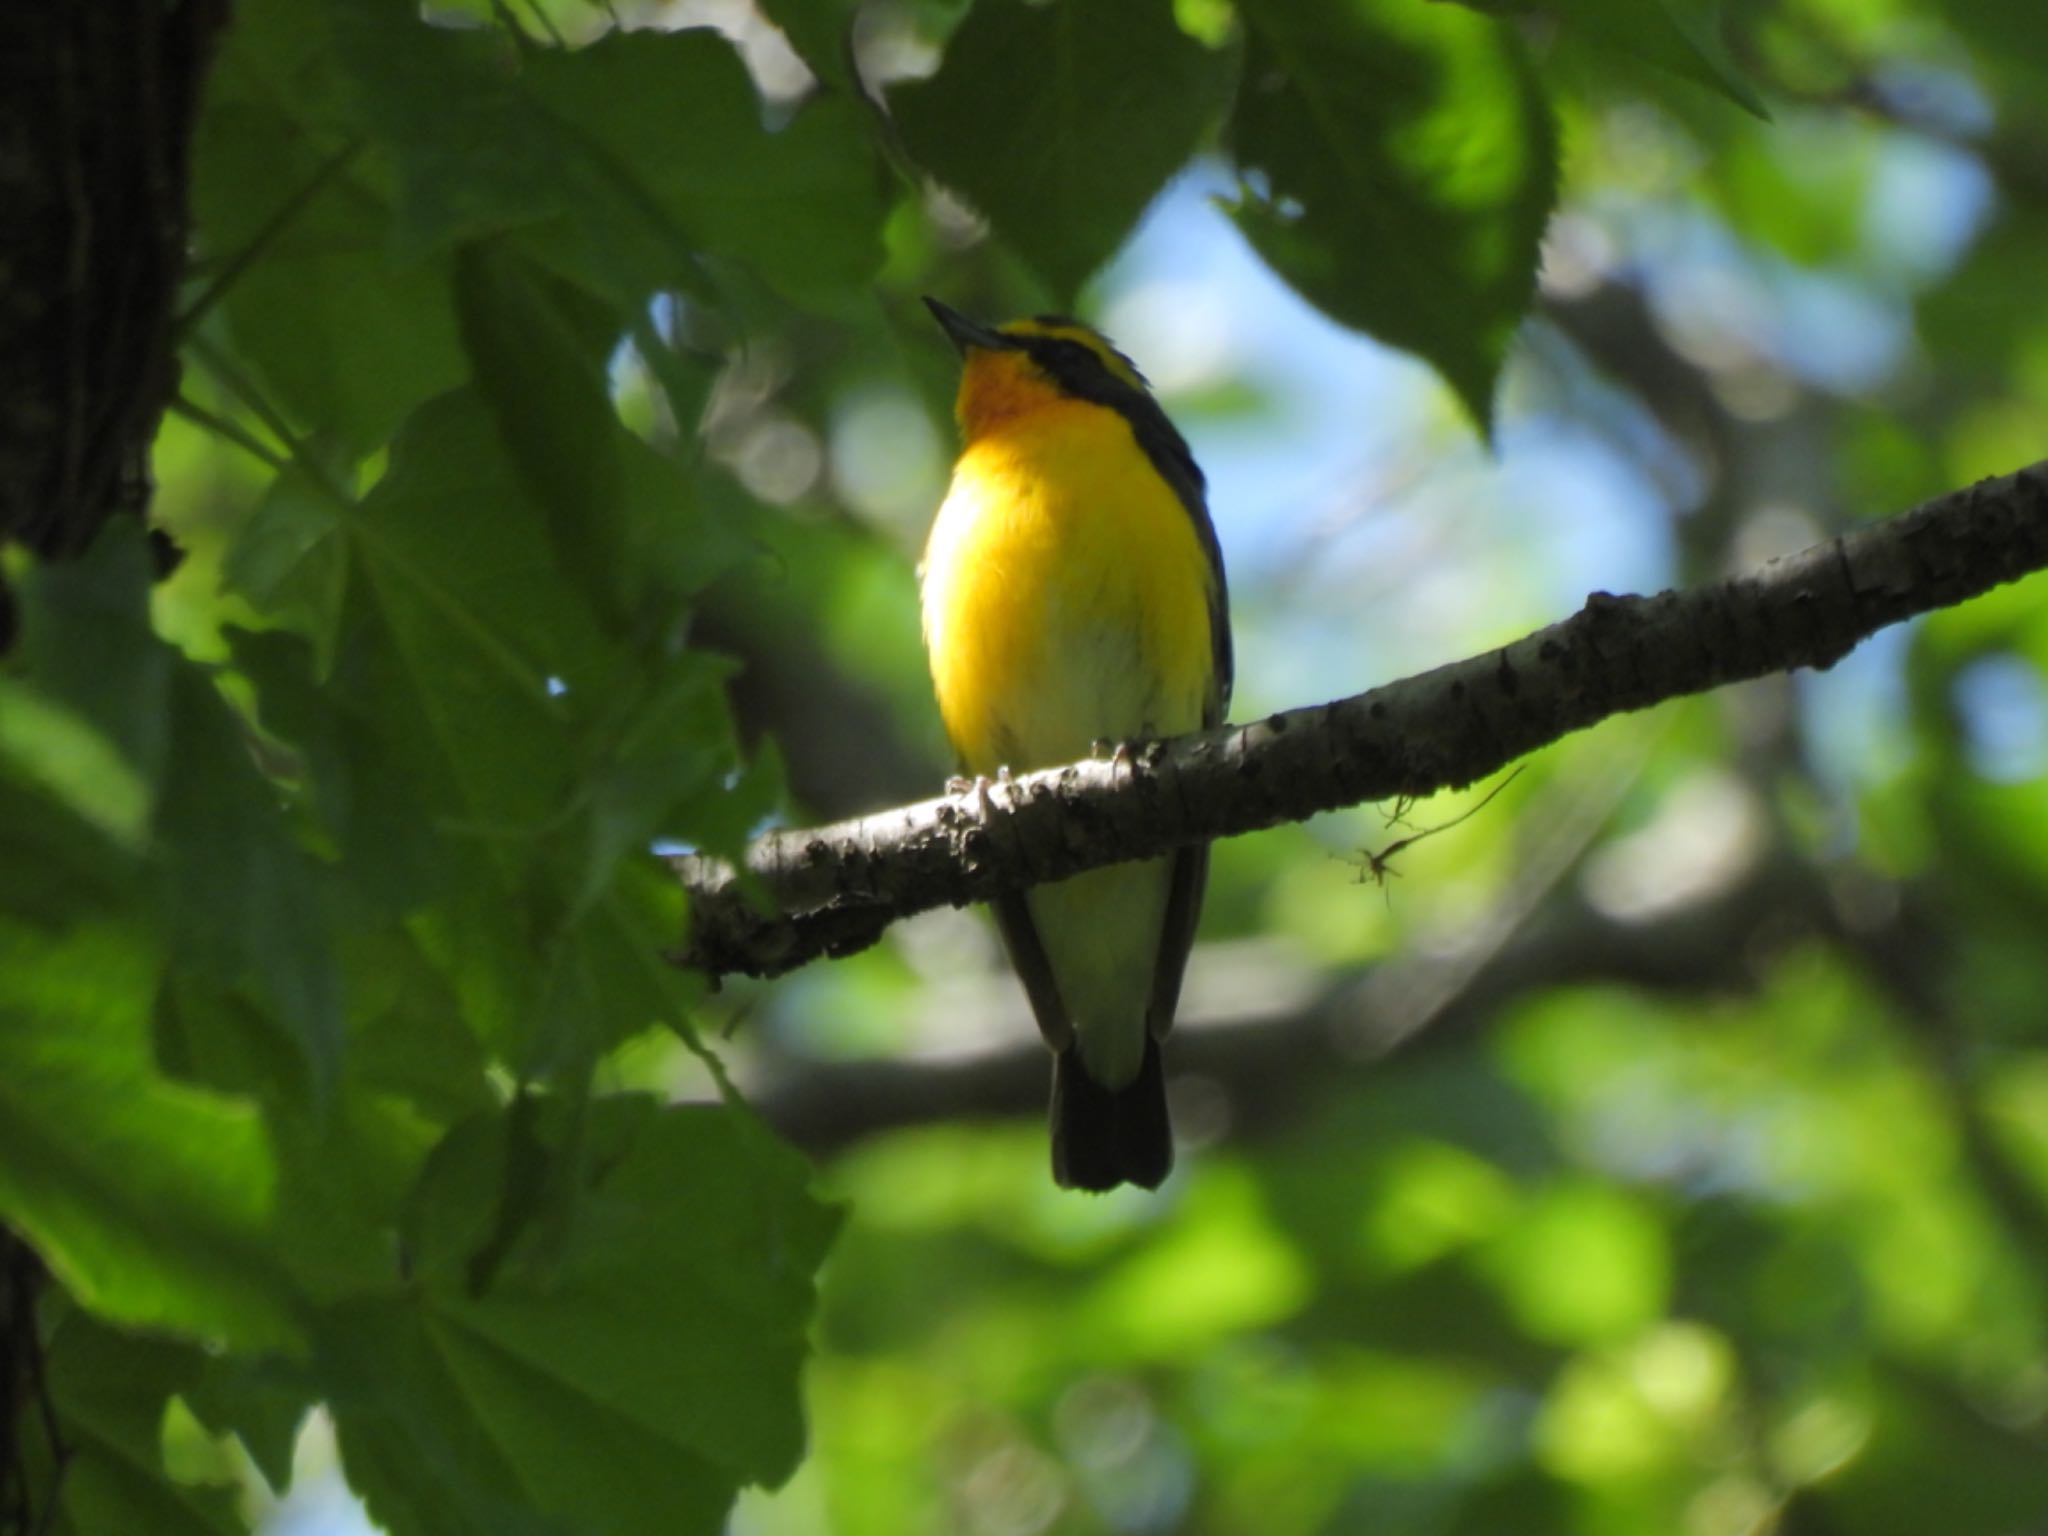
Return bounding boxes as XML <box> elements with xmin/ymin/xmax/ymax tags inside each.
<box><xmin>924</xmin><ymin>299</ymin><xmax>1231</xmax><ymax>1190</ymax></box>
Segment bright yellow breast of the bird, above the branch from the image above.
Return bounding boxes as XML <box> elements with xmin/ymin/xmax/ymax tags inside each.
<box><xmin>924</xmin><ymin>399</ymin><xmax>1214</xmax><ymax>774</ymax></box>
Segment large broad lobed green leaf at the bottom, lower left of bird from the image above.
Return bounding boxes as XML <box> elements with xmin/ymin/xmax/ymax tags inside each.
<box><xmin>324</xmin><ymin>1098</ymin><xmax>836</xmax><ymax>1536</ymax></box>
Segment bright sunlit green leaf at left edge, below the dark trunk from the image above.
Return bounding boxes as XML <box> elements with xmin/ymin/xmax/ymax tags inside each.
<box><xmin>0</xmin><ymin>922</ymin><xmax>297</xmax><ymax>1348</ymax></box>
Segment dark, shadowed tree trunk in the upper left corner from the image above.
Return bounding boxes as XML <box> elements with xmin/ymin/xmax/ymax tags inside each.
<box><xmin>0</xmin><ymin>0</ymin><xmax>227</xmax><ymax>557</ymax></box>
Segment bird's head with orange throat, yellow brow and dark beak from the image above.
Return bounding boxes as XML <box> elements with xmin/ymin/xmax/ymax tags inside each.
<box><xmin>926</xmin><ymin>299</ymin><xmax>1151</xmax><ymax>442</ymax></box>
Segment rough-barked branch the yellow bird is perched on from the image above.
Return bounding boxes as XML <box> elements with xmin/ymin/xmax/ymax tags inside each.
<box><xmin>674</xmin><ymin>461</ymin><xmax>2048</xmax><ymax>977</ymax></box>
